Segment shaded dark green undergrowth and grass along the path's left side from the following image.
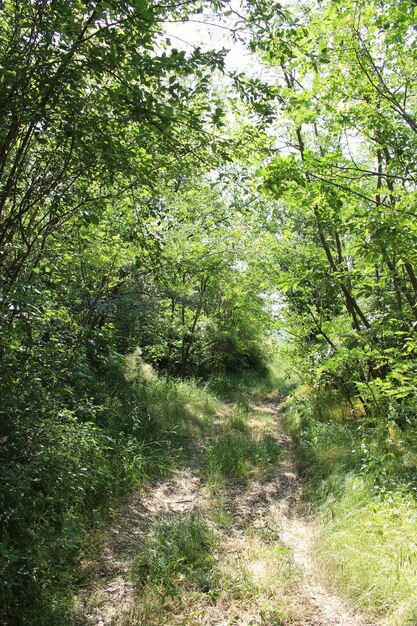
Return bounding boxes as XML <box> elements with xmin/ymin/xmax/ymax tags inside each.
<box><xmin>0</xmin><ymin>360</ymin><xmax>218</xmax><ymax>626</ymax></box>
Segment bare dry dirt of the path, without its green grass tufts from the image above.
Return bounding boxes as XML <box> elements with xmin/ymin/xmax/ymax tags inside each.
<box><xmin>75</xmin><ymin>400</ymin><xmax>376</xmax><ymax>626</ymax></box>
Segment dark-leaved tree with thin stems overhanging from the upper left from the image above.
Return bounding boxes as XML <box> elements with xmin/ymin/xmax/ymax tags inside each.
<box><xmin>0</xmin><ymin>0</ymin><xmax>229</xmax><ymax>288</ymax></box>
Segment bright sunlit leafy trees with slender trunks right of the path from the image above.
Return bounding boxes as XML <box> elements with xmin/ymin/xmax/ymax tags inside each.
<box><xmin>244</xmin><ymin>0</ymin><xmax>417</xmax><ymax>414</ymax></box>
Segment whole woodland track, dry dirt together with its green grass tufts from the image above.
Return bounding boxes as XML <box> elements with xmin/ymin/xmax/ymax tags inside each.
<box><xmin>74</xmin><ymin>398</ymin><xmax>376</xmax><ymax>626</ymax></box>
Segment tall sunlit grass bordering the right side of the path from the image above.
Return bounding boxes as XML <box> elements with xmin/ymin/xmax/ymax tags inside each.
<box><xmin>284</xmin><ymin>382</ymin><xmax>417</xmax><ymax>626</ymax></box>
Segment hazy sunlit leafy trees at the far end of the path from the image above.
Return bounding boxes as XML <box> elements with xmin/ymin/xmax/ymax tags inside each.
<box><xmin>109</xmin><ymin>179</ymin><xmax>271</xmax><ymax>379</ymax></box>
